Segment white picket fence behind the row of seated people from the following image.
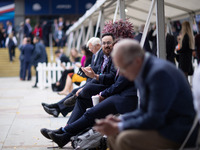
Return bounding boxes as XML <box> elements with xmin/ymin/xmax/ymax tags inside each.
<box><xmin>36</xmin><ymin>61</ymin><xmax>74</xmax><ymax>89</ymax></box>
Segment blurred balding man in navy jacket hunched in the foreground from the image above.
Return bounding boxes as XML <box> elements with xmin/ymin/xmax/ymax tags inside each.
<box><xmin>95</xmin><ymin>39</ymin><xmax>198</xmax><ymax>150</ymax></box>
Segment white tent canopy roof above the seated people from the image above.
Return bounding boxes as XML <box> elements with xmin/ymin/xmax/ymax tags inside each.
<box><xmin>67</xmin><ymin>0</ymin><xmax>200</xmax><ymax>58</ymax></box>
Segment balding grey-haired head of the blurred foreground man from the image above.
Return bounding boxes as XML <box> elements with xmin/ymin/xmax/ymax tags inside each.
<box><xmin>111</xmin><ymin>39</ymin><xmax>144</xmax><ymax>81</ymax></box>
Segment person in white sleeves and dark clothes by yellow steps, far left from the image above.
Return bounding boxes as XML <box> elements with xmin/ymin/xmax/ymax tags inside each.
<box><xmin>6</xmin><ymin>32</ymin><xmax>17</xmax><ymax>62</ymax></box>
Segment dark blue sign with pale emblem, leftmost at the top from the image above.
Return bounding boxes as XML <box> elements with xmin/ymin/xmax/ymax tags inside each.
<box><xmin>25</xmin><ymin>0</ymin><xmax>49</xmax><ymax>15</ymax></box>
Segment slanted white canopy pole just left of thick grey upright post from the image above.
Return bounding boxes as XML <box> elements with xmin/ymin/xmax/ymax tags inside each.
<box><xmin>140</xmin><ymin>0</ymin><xmax>156</xmax><ymax>47</ymax></box>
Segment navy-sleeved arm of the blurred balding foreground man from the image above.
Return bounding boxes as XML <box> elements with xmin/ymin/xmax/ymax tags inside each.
<box><xmin>119</xmin><ymin>71</ymin><xmax>177</xmax><ymax>129</ymax></box>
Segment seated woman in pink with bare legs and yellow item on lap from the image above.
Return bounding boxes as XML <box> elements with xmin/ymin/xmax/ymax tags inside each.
<box><xmin>58</xmin><ymin>45</ymin><xmax>92</xmax><ymax>95</ymax></box>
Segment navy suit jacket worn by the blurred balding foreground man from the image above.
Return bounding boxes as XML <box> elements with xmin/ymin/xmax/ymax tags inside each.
<box><xmin>122</xmin><ymin>54</ymin><xmax>197</xmax><ymax>145</ymax></box>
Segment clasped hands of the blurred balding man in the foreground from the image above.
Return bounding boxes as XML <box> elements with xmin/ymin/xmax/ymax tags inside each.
<box><xmin>93</xmin><ymin>115</ymin><xmax>119</xmax><ymax>136</ymax></box>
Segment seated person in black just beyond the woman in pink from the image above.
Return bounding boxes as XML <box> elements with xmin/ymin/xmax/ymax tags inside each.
<box><xmin>52</xmin><ymin>48</ymin><xmax>80</xmax><ymax>91</ymax></box>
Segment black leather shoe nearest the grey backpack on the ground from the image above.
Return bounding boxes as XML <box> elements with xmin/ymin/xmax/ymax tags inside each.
<box><xmin>48</xmin><ymin>132</ymin><xmax>72</xmax><ymax>148</ymax></box>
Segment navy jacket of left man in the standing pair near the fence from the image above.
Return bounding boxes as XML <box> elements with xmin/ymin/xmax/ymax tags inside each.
<box><xmin>22</xmin><ymin>44</ymin><xmax>34</xmax><ymax>62</ymax></box>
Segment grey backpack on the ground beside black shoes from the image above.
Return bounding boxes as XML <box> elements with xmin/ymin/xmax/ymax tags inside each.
<box><xmin>71</xmin><ymin>128</ymin><xmax>107</xmax><ymax>150</ymax></box>
